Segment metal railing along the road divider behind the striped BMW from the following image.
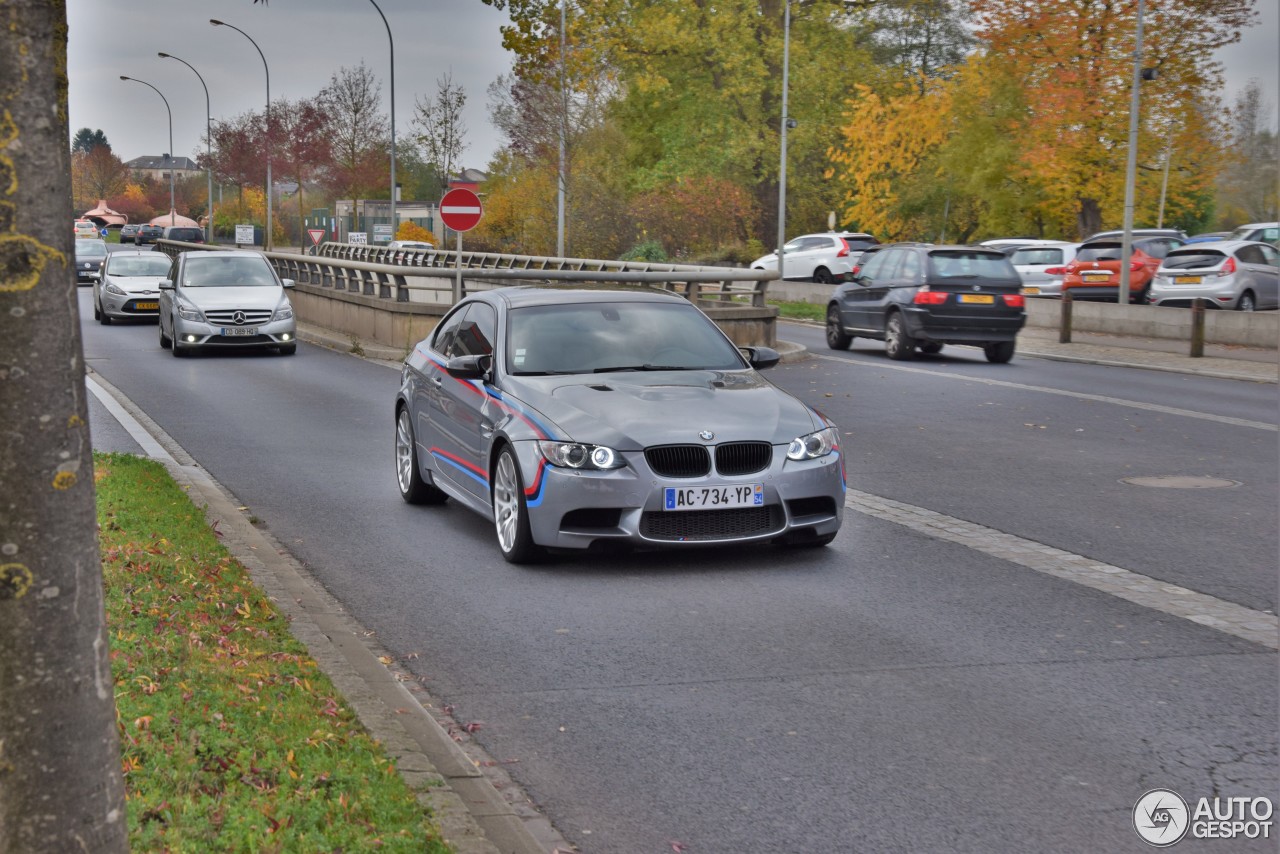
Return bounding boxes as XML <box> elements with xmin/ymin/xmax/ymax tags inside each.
<box><xmin>156</xmin><ymin>239</ymin><xmax>777</xmax><ymax>309</ymax></box>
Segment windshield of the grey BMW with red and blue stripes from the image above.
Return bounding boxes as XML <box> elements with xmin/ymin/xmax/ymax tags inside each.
<box><xmin>507</xmin><ymin>302</ymin><xmax>746</xmax><ymax>374</ymax></box>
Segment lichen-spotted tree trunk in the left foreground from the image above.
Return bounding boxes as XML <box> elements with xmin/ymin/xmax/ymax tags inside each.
<box><xmin>0</xmin><ymin>0</ymin><xmax>128</xmax><ymax>854</ymax></box>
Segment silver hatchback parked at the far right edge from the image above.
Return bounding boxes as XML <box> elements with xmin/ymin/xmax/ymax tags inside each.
<box><xmin>1147</xmin><ymin>241</ymin><xmax>1280</xmax><ymax>311</ymax></box>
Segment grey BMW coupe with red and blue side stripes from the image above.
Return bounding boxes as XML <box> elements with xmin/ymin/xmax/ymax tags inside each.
<box><xmin>394</xmin><ymin>288</ymin><xmax>845</xmax><ymax>563</ymax></box>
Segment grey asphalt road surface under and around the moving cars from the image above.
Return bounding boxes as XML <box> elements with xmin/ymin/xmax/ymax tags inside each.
<box><xmin>81</xmin><ymin>288</ymin><xmax>1280</xmax><ymax>854</ymax></box>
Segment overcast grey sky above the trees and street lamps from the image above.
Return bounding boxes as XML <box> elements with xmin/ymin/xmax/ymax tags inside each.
<box><xmin>67</xmin><ymin>0</ymin><xmax>1280</xmax><ymax>169</ymax></box>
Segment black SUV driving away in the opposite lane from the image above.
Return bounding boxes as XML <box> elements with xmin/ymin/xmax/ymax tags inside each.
<box><xmin>827</xmin><ymin>245</ymin><xmax>1027</xmax><ymax>362</ymax></box>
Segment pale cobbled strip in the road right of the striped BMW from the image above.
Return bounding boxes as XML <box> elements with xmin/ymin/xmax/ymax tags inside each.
<box><xmin>845</xmin><ymin>489</ymin><xmax>1280</xmax><ymax>649</ymax></box>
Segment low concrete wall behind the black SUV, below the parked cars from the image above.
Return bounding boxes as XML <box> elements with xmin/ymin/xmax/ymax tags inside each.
<box><xmin>769</xmin><ymin>282</ymin><xmax>1280</xmax><ymax>350</ymax></box>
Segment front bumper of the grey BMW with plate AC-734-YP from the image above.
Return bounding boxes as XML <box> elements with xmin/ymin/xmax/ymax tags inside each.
<box><xmin>516</xmin><ymin>442</ymin><xmax>845</xmax><ymax>549</ymax></box>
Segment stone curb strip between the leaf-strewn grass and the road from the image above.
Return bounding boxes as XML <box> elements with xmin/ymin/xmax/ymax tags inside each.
<box><xmin>86</xmin><ymin>369</ymin><xmax>575</xmax><ymax>854</ymax></box>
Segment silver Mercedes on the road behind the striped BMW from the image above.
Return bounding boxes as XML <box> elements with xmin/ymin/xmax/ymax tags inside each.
<box><xmin>160</xmin><ymin>250</ymin><xmax>298</xmax><ymax>356</ymax></box>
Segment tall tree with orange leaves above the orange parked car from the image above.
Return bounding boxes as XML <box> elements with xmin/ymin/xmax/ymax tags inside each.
<box><xmin>973</xmin><ymin>0</ymin><xmax>1254</xmax><ymax>237</ymax></box>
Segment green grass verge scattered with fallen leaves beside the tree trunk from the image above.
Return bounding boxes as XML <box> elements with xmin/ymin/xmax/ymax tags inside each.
<box><xmin>95</xmin><ymin>455</ymin><xmax>449</xmax><ymax>854</ymax></box>
